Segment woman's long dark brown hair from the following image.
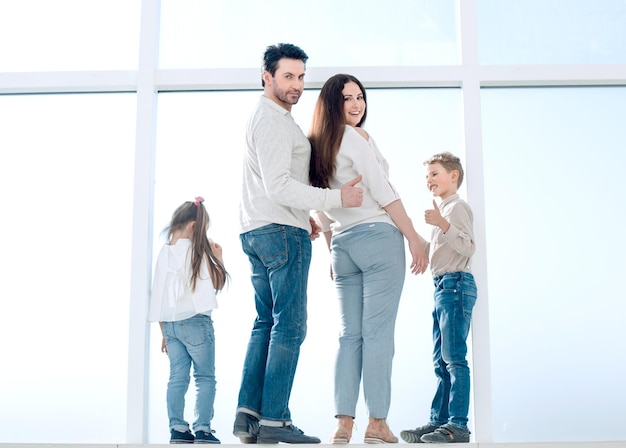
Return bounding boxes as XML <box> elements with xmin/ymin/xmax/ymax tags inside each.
<box><xmin>308</xmin><ymin>73</ymin><xmax>367</xmax><ymax>188</ymax></box>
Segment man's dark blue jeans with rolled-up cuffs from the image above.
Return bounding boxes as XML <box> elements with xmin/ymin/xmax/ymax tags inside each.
<box><xmin>238</xmin><ymin>224</ymin><xmax>311</xmax><ymax>426</ymax></box>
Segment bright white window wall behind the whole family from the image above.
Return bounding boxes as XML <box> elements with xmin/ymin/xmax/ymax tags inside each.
<box><xmin>0</xmin><ymin>0</ymin><xmax>626</xmax><ymax>443</ymax></box>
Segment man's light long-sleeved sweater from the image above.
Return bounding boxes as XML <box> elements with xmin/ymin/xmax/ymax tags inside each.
<box><xmin>239</xmin><ymin>96</ymin><xmax>341</xmax><ymax>233</ymax></box>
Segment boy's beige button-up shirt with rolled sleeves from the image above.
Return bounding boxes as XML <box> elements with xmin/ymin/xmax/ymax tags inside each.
<box><xmin>429</xmin><ymin>194</ymin><xmax>476</xmax><ymax>277</ymax></box>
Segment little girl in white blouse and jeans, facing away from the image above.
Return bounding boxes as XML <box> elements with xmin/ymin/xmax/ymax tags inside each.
<box><xmin>148</xmin><ymin>196</ymin><xmax>228</xmax><ymax>443</ymax></box>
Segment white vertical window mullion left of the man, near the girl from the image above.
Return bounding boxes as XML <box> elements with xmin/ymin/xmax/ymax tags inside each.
<box><xmin>126</xmin><ymin>0</ymin><xmax>161</xmax><ymax>443</ymax></box>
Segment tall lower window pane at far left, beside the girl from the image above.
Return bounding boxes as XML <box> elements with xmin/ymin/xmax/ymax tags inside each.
<box><xmin>0</xmin><ymin>94</ymin><xmax>135</xmax><ymax>443</ymax></box>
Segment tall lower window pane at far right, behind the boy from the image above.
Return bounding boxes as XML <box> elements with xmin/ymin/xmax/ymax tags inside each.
<box><xmin>482</xmin><ymin>87</ymin><xmax>626</xmax><ymax>442</ymax></box>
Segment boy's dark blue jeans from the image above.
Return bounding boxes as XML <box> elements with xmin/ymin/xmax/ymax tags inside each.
<box><xmin>430</xmin><ymin>272</ymin><xmax>477</xmax><ymax>428</ymax></box>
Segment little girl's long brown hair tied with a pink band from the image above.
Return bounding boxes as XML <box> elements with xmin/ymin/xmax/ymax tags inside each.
<box><xmin>167</xmin><ymin>198</ymin><xmax>228</xmax><ymax>291</ymax></box>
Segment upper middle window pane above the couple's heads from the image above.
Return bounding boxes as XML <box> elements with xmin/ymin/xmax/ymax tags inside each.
<box><xmin>160</xmin><ymin>0</ymin><xmax>459</xmax><ymax>69</ymax></box>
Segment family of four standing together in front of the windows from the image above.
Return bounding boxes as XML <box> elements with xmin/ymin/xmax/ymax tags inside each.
<box><xmin>148</xmin><ymin>43</ymin><xmax>477</xmax><ymax>444</ymax></box>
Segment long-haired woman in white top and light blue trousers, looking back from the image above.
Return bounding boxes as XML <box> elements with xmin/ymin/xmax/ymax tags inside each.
<box><xmin>309</xmin><ymin>74</ymin><xmax>428</xmax><ymax>443</ymax></box>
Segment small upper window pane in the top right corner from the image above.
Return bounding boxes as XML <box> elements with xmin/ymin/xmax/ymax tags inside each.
<box><xmin>478</xmin><ymin>0</ymin><xmax>626</xmax><ymax>65</ymax></box>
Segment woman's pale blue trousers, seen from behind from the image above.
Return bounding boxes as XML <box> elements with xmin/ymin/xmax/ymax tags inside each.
<box><xmin>331</xmin><ymin>223</ymin><xmax>406</xmax><ymax>418</ymax></box>
